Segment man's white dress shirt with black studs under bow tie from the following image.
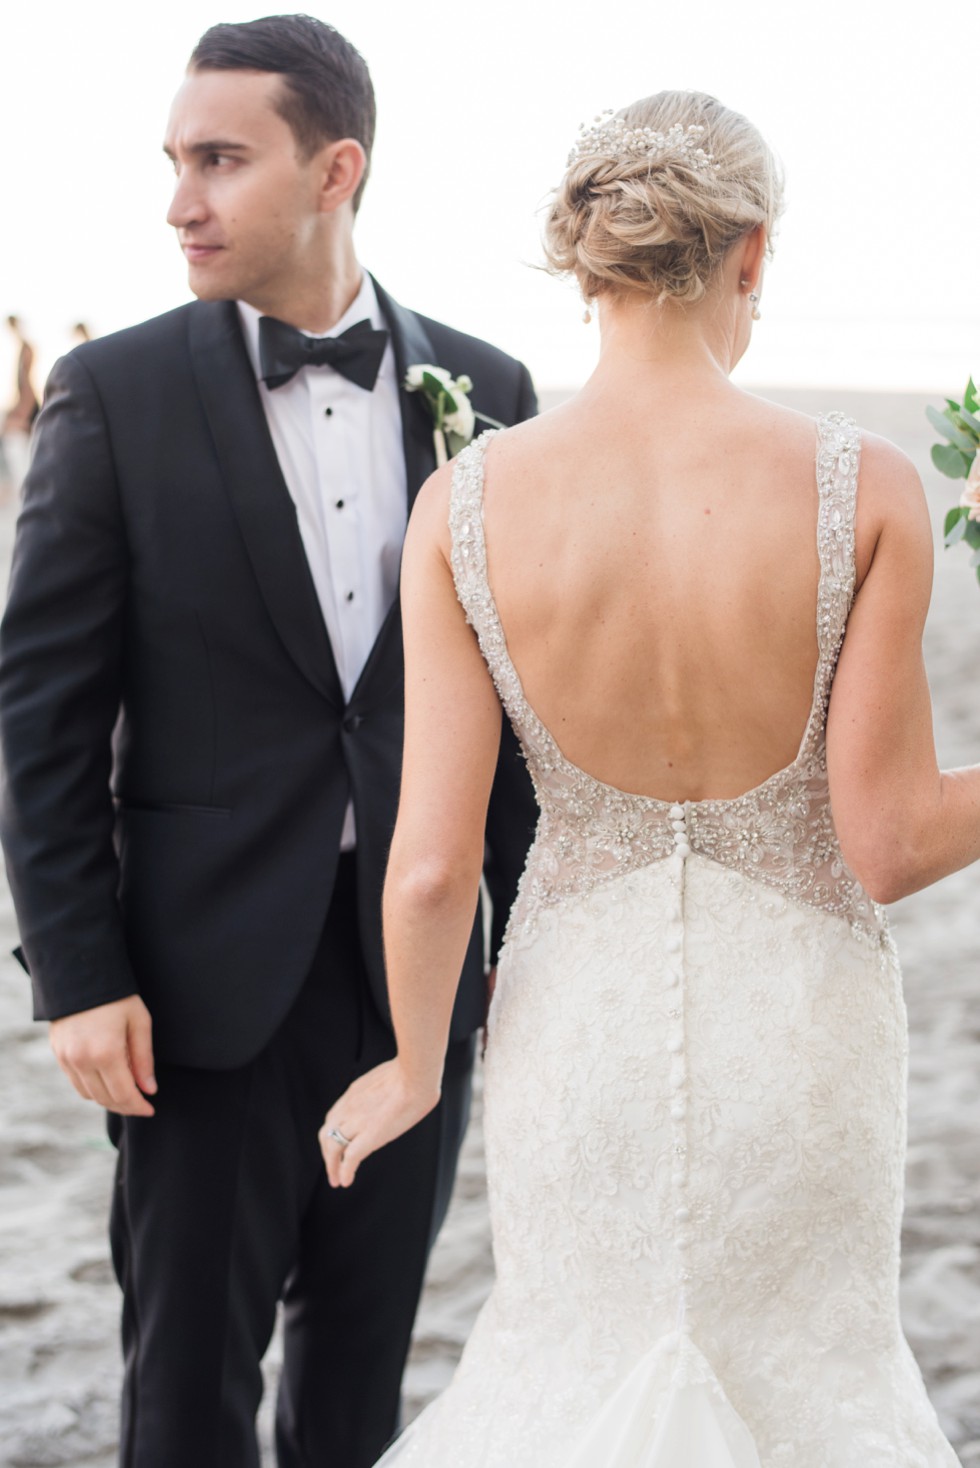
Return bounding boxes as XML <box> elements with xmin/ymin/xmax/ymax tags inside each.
<box><xmin>238</xmin><ymin>273</ymin><xmax>408</xmax><ymax>850</ymax></box>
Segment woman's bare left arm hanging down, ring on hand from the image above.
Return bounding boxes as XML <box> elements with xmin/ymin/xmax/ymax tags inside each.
<box><xmin>320</xmin><ymin>467</ymin><xmax>502</xmax><ymax>1186</ymax></box>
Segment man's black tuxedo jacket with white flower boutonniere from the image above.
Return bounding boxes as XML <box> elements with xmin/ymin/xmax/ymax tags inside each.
<box><xmin>0</xmin><ymin>277</ymin><xmax>535</xmax><ymax>1069</ymax></box>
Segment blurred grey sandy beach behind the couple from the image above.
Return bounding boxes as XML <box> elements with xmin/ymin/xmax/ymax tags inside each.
<box><xmin>0</xmin><ymin>390</ymin><xmax>980</xmax><ymax>1468</ymax></box>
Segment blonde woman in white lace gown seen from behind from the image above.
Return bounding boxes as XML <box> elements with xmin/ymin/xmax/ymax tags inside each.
<box><xmin>321</xmin><ymin>92</ymin><xmax>962</xmax><ymax>1468</ymax></box>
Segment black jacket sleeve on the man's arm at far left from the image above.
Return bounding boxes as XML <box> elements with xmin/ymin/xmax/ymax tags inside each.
<box><xmin>0</xmin><ymin>354</ymin><xmax>136</xmax><ymax>1019</ymax></box>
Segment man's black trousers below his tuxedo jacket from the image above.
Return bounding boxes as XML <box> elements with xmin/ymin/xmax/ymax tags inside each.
<box><xmin>109</xmin><ymin>857</ymin><xmax>474</xmax><ymax>1468</ymax></box>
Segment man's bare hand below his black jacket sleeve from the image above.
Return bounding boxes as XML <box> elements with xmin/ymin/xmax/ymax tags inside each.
<box><xmin>50</xmin><ymin>994</ymin><xmax>157</xmax><ymax>1116</ymax></box>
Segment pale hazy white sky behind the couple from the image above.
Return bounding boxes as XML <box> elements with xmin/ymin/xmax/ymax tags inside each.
<box><xmin>0</xmin><ymin>0</ymin><xmax>980</xmax><ymax>392</ymax></box>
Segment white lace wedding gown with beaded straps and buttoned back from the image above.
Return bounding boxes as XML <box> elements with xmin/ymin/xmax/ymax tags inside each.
<box><xmin>372</xmin><ymin>414</ymin><xmax>957</xmax><ymax>1468</ymax></box>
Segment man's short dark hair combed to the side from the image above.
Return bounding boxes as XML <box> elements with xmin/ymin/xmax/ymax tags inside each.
<box><xmin>188</xmin><ymin>15</ymin><xmax>376</xmax><ymax>210</ymax></box>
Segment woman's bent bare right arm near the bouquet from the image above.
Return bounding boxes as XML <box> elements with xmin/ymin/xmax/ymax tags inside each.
<box><xmin>827</xmin><ymin>439</ymin><xmax>980</xmax><ymax>903</ymax></box>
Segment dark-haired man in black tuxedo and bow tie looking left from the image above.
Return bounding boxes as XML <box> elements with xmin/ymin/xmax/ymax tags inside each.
<box><xmin>0</xmin><ymin>16</ymin><xmax>535</xmax><ymax>1468</ymax></box>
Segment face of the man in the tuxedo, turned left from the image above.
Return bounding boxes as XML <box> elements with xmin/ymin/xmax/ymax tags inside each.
<box><xmin>164</xmin><ymin>70</ymin><xmax>323</xmax><ymax>310</ymax></box>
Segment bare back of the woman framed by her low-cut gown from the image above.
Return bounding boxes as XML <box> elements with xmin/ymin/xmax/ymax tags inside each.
<box><xmin>484</xmin><ymin>385</ymin><xmax>870</xmax><ymax>800</ymax></box>
